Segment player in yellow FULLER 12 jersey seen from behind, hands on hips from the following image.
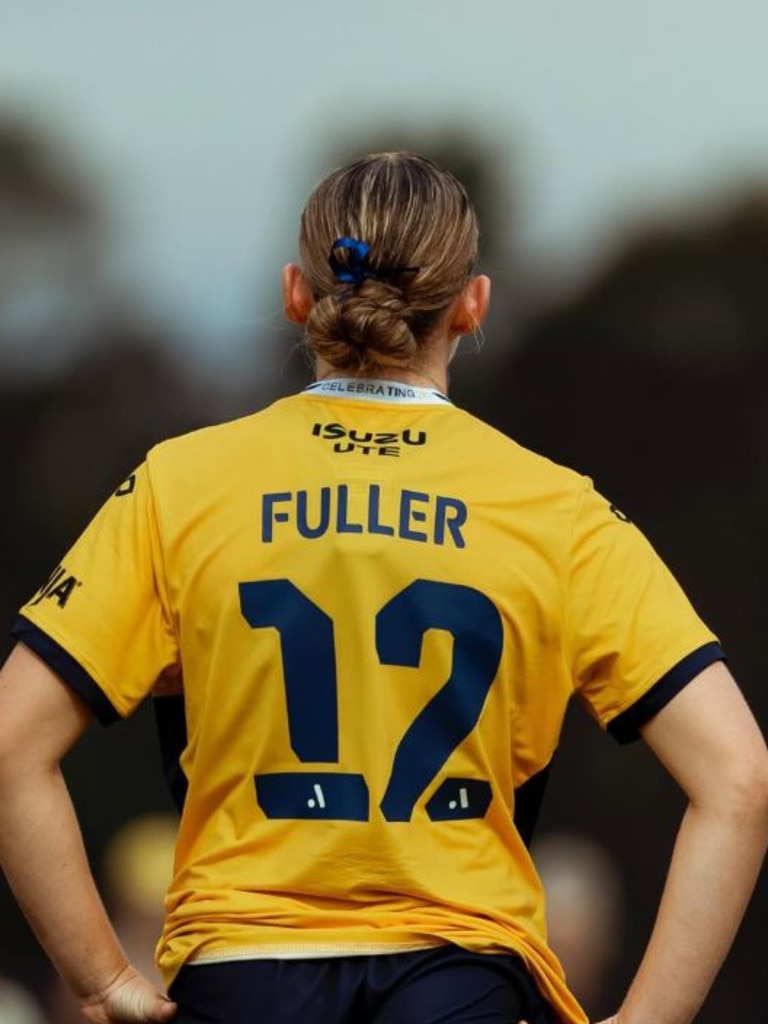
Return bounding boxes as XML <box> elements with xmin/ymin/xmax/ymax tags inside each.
<box><xmin>0</xmin><ymin>154</ymin><xmax>768</xmax><ymax>1024</ymax></box>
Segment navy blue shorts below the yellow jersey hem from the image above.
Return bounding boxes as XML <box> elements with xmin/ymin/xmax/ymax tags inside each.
<box><xmin>170</xmin><ymin>945</ymin><xmax>556</xmax><ymax>1024</ymax></box>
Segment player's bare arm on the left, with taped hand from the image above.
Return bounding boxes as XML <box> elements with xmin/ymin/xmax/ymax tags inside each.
<box><xmin>0</xmin><ymin>645</ymin><xmax>175</xmax><ymax>1024</ymax></box>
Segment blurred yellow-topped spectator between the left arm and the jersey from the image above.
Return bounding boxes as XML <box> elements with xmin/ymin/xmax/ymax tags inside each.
<box><xmin>50</xmin><ymin>814</ymin><xmax>178</xmax><ymax>1024</ymax></box>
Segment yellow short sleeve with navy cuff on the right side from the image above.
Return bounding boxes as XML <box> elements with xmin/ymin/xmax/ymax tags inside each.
<box><xmin>565</xmin><ymin>481</ymin><xmax>724</xmax><ymax>742</ymax></box>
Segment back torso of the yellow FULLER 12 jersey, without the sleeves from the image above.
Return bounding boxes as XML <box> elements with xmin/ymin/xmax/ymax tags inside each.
<box><xmin>150</xmin><ymin>381</ymin><xmax>580</xmax><ymax>1015</ymax></box>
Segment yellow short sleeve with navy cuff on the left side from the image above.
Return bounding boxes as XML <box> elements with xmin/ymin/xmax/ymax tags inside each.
<box><xmin>12</xmin><ymin>464</ymin><xmax>178</xmax><ymax>723</ymax></box>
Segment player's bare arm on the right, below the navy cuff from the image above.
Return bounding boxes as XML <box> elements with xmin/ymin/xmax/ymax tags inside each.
<box><xmin>604</xmin><ymin>663</ymin><xmax>768</xmax><ymax>1024</ymax></box>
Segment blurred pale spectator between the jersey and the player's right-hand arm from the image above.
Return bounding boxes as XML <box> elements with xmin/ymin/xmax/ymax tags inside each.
<box><xmin>532</xmin><ymin>833</ymin><xmax>625</xmax><ymax>1019</ymax></box>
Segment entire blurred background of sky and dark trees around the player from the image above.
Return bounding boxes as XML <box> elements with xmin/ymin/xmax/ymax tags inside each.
<box><xmin>0</xmin><ymin>0</ymin><xmax>768</xmax><ymax>1024</ymax></box>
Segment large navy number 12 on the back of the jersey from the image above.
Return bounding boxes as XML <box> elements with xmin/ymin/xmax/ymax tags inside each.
<box><xmin>240</xmin><ymin>580</ymin><xmax>504</xmax><ymax>821</ymax></box>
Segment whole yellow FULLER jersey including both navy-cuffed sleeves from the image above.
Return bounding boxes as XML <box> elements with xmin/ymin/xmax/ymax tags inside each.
<box><xmin>15</xmin><ymin>381</ymin><xmax>722</xmax><ymax>1022</ymax></box>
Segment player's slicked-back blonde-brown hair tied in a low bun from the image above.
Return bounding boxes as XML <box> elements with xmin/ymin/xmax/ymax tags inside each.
<box><xmin>300</xmin><ymin>153</ymin><xmax>477</xmax><ymax>374</ymax></box>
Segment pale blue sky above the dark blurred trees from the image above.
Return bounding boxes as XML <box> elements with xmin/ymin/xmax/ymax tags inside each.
<box><xmin>0</xmin><ymin>0</ymin><xmax>768</xmax><ymax>368</ymax></box>
